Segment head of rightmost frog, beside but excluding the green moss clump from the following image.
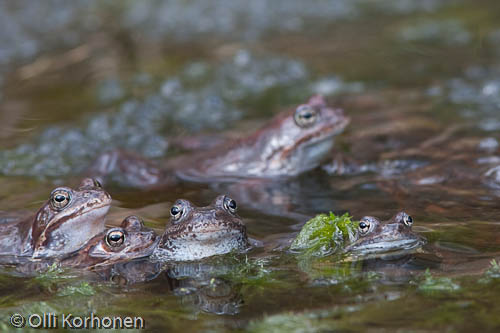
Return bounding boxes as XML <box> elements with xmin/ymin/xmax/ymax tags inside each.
<box><xmin>344</xmin><ymin>212</ymin><xmax>425</xmax><ymax>256</ymax></box>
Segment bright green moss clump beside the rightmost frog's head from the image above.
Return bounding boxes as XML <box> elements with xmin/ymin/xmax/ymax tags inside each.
<box><xmin>290</xmin><ymin>212</ymin><xmax>356</xmax><ymax>257</ymax></box>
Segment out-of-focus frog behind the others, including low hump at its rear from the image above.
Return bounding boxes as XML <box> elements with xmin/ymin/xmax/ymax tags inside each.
<box><xmin>90</xmin><ymin>96</ymin><xmax>349</xmax><ymax>188</ymax></box>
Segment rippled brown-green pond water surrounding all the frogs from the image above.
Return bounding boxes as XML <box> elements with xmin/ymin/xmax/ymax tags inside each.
<box><xmin>0</xmin><ymin>0</ymin><xmax>500</xmax><ymax>332</ymax></box>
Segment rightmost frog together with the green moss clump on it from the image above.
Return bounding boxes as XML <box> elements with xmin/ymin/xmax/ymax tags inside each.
<box><xmin>291</xmin><ymin>212</ymin><xmax>425</xmax><ymax>256</ymax></box>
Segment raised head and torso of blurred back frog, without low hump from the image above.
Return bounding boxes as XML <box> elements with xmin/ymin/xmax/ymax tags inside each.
<box><xmin>176</xmin><ymin>96</ymin><xmax>349</xmax><ymax>182</ymax></box>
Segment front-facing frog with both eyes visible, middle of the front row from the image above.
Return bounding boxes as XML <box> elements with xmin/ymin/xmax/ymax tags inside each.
<box><xmin>152</xmin><ymin>195</ymin><xmax>249</xmax><ymax>261</ymax></box>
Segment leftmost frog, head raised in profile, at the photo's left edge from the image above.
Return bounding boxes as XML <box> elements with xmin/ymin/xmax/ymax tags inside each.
<box><xmin>0</xmin><ymin>178</ymin><xmax>111</xmax><ymax>258</ymax></box>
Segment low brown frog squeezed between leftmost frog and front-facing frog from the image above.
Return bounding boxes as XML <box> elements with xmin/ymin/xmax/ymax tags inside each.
<box><xmin>61</xmin><ymin>215</ymin><xmax>158</xmax><ymax>268</ymax></box>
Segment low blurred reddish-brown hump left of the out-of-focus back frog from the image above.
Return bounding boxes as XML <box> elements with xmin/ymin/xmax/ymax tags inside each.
<box><xmin>87</xmin><ymin>150</ymin><xmax>175</xmax><ymax>189</ymax></box>
